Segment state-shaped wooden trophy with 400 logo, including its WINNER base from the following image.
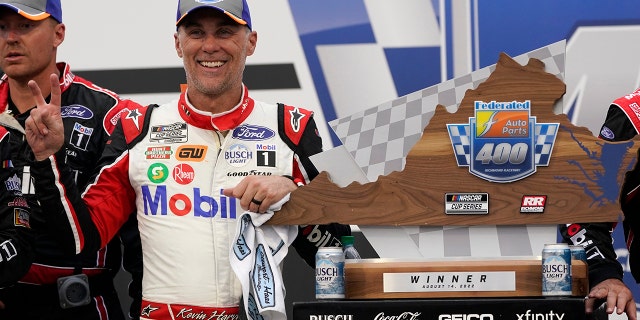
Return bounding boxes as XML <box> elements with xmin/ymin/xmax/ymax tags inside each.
<box><xmin>269</xmin><ymin>45</ymin><xmax>637</xmax><ymax>299</ymax></box>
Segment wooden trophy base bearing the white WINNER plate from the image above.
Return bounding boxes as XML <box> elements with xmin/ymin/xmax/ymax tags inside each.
<box><xmin>345</xmin><ymin>257</ymin><xmax>589</xmax><ymax>299</ymax></box>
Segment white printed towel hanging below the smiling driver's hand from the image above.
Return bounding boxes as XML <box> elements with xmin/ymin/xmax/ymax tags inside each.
<box><xmin>230</xmin><ymin>195</ymin><xmax>298</xmax><ymax>320</ymax></box>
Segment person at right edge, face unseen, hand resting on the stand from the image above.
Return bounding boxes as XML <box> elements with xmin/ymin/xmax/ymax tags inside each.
<box><xmin>560</xmin><ymin>89</ymin><xmax>640</xmax><ymax>320</ymax></box>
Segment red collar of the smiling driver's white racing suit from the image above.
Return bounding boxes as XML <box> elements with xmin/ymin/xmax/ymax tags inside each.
<box><xmin>178</xmin><ymin>84</ymin><xmax>254</xmax><ymax>131</ymax></box>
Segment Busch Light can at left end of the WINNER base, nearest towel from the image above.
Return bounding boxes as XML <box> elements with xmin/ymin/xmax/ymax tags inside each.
<box><xmin>316</xmin><ymin>247</ymin><xmax>344</xmax><ymax>299</ymax></box>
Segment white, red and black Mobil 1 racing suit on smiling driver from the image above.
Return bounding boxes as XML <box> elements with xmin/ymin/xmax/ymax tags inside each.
<box><xmin>32</xmin><ymin>86</ymin><xmax>351</xmax><ymax>318</ymax></box>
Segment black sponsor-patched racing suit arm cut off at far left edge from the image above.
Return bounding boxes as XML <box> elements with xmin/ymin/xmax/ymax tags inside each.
<box><xmin>0</xmin><ymin>126</ymin><xmax>34</xmax><ymax>290</ymax></box>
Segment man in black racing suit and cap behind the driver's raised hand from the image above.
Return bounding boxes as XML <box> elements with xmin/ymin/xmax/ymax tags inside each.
<box><xmin>0</xmin><ymin>0</ymin><xmax>142</xmax><ymax>320</ymax></box>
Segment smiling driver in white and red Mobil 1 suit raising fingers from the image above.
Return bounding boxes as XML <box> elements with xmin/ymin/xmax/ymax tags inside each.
<box><xmin>22</xmin><ymin>0</ymin><xmax>351</xmax><ymax>319</ymax></box>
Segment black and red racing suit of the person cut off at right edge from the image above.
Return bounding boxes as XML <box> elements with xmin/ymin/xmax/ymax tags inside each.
<box><xmin>560</xmin><ymin>89</ymin><xmax>640</xmax><ymax>287</ymax></box>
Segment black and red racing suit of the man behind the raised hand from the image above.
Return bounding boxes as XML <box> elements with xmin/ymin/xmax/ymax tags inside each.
<box><xmin>0</xmin><ymin>63</ymin><xmax>142</xmax><ymax>320</ymax></box>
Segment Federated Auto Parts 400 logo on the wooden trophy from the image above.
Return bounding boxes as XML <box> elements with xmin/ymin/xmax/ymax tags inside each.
<box><xmin>447</xmin><ymin>100</ymin><xmax>560</xmax><ymax>183</ymax></box>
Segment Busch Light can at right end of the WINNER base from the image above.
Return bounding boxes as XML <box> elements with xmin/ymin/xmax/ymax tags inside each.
<box><xmin>542</xmin><ymin>243</ymin><xmax>573</xmax><ymax>296</ymax></box>
